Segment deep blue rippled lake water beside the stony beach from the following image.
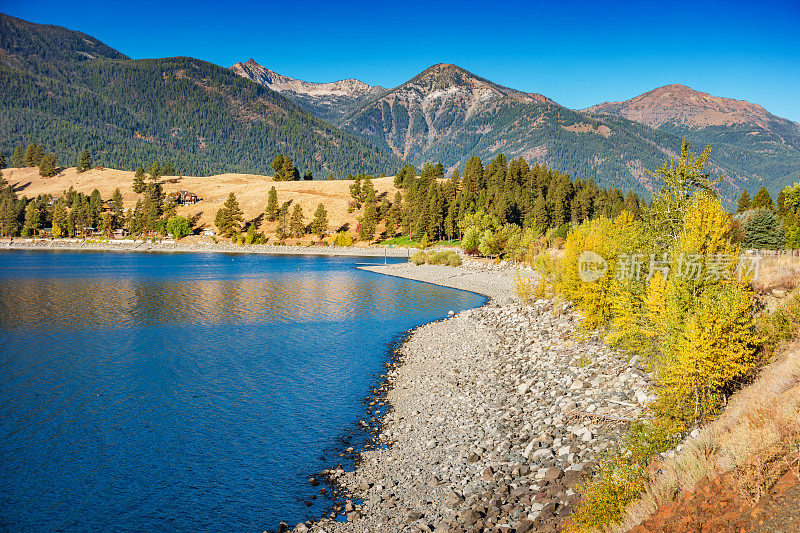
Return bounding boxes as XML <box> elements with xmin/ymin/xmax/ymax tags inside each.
<box><xmin>0</xmin><ymin>251</ymin><xmax>485</xmax><ymax>532</ymax></box>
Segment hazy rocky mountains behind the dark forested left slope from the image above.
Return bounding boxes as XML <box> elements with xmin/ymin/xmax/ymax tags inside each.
<box><xmin>232</xmin><ymin>59</ymin><xmax>800</xmax><ymax>205</ymax></box>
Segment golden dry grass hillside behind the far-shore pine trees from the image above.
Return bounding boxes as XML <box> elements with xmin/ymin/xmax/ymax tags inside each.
<box><xmin>3</xmin><ymin>167</ymin><xmax>397</xmax><ymax>238</ymax></box>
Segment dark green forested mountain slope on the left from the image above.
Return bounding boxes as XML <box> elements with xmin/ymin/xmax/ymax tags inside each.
<box><xmin>0</xmin><ymin>14</ymin><xmax>400</xmax><ymax>176</ymax></box>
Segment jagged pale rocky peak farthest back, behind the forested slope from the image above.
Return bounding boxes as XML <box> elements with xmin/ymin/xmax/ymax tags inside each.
<box><xmin>231</xmin><ymin>58</ymin><xmax>386</xmax><ymax>124</ymax></box>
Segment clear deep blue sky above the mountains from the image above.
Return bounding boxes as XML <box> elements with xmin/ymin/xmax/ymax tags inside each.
<box><xmin>0</xmin><ymin>0</ymin><xmax>800</xmax><ymax>122</ymax></box>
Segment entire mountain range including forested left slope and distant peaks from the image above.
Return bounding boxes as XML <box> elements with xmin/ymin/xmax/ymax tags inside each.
<box><xmin>0</xmin><ymin>10</ymin><xmax>800</xmax><ymax>206</ymax></box>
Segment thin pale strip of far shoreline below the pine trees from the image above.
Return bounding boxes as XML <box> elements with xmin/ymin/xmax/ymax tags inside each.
<box><xmin>0</xmin><ymin>238</ymin><xmax>415</xmax><ymax>258</ymax></box>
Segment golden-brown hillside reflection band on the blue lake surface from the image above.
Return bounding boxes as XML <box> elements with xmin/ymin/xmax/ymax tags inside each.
<box><xmin>0</xmin><ymin>272</ymin><xmax>462</xmax><ymax>331</ymax></box>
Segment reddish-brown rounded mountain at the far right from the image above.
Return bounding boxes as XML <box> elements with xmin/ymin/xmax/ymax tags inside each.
<box><xmin>584</xmin><ymin>84</ymin><xmax>800</xmax><ymax>192</ymax></box>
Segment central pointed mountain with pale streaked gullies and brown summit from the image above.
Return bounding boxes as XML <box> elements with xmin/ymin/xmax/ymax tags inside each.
<box><xmin>340</xmin><ymin>64</ymin><xmax>680</xmax><ymax>192</ymax></box>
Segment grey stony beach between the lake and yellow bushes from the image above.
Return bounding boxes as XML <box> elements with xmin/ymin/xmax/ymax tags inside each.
<box><xmin>294</xmin><ymin>261</ymin><xmax>649</xmax><ymax>533</ymax></box>
